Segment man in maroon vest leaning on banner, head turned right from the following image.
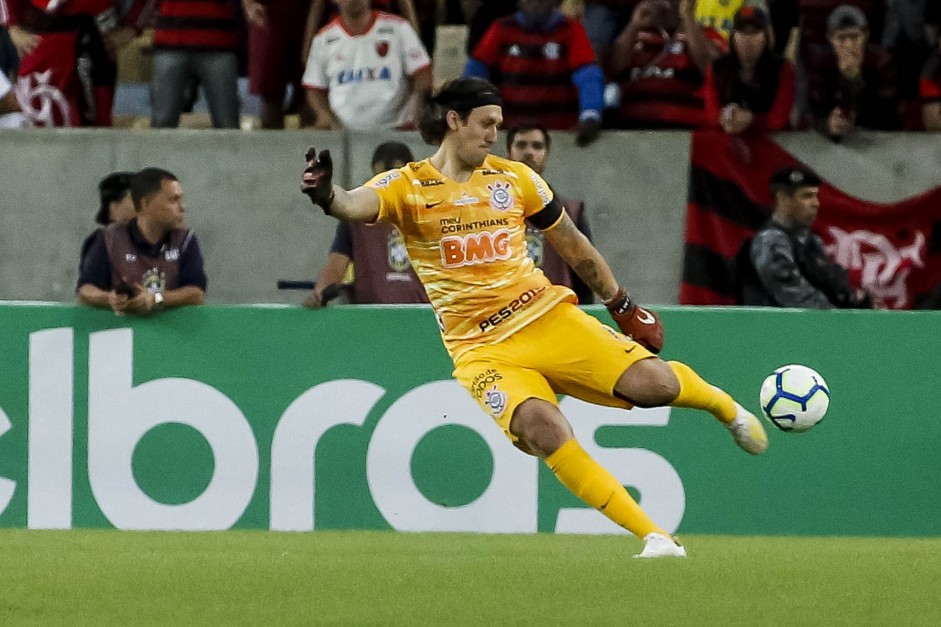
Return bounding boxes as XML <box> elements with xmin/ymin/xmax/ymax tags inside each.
<box><xmin>78</xmin><ymin>168</ymin><xmax>207</xmax><ymax>315</ymax></box>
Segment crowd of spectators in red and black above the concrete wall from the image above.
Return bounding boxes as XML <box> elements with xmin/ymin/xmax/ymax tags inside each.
<box><xmin>0</xmin><ymin>0</ymin><xmax>941</xmax><ymax>132</ymax></box>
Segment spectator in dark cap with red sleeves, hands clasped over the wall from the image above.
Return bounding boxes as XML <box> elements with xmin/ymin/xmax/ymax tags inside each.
<box><xmin>706</xmin><ymin>5</ymin><xmax>794</xmax><ymax>135</ymax></box>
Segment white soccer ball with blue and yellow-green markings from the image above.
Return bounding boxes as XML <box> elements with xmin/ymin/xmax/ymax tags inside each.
<box><xmin>759</xmin><ymin>364</ymin><xmax>830</xmax><ymax>433</ymax></box>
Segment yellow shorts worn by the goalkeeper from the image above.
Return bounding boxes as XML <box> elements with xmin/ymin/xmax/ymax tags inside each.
<box><xmin>453</xmin><ymin>303</ymin><xmax>654</xmax><ymax>442</ymax></box>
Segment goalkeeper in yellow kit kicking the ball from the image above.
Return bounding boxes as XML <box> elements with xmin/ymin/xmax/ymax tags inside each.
<box><xmin>301</xmin><ymin>78</ymin><xmax>768</xmax><ymax>557</ymax></box>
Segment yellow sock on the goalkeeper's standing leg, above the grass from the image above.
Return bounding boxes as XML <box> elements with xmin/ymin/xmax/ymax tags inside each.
<box><xmin>546</xmin><ymin>440</ymin><xmax>666</xmax><ymax>538</ymax></box>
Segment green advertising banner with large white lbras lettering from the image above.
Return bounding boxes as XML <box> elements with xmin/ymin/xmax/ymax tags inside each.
<box><xmin>0</xmin><ymin>303</ymin><xmax>941</xmax><ymax>536</ymax></box>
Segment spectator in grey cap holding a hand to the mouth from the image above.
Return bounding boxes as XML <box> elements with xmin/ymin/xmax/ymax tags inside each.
<box><xmin>808</xmin><ymin>5</ymin><xmax>901</xmax><ymax>141</ymax></box>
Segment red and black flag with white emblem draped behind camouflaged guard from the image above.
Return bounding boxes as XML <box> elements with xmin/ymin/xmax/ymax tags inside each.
<box><xmin>679</xmin><ymin>132</ymin><xmax>941</xmax><ymax>309</ymax></box>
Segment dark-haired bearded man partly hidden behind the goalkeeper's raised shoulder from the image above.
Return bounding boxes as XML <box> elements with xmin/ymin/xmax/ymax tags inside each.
<box><xmin>506</xmin><ymin>125</ymin><xmax>594</xmax><ymax>305</ymax></box>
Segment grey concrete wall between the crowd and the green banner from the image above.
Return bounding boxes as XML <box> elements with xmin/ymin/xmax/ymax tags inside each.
<box><xmin>0</xmin><ymin>130</ymin><xmax>941</xmax><ymax>304</ymax></box>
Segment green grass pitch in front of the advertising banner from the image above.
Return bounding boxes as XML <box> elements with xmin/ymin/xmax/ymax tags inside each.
<box><xmin>0</xmin><ymin>530</ymin><xmax>941</xmax><ymax>627</ymax></box>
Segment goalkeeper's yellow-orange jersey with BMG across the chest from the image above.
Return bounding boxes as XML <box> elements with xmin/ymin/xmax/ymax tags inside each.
<box><xmin>366</xmin><ymin>155</ymin><xmax>577</xmax><ymax>359</ymax></box>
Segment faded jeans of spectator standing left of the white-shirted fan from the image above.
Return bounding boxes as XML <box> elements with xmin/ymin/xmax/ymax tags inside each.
<box><xmin>150</xmin><ymin>49</ymin><xmax>239</xmax><ymax>128</ymax></box>
